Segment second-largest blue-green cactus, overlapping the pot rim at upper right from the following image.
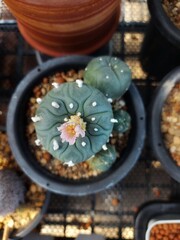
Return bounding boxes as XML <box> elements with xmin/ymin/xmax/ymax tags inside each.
<box><xmin>84</xmin><ymin>56</ymin><xmax>132</xmax><ymax>99</ymax></box>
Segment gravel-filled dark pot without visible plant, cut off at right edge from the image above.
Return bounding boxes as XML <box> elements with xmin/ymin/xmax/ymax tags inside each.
<box><xmin>150</xmin><ymin>67</ymin><xmax>180</xmax><ymax>182</ymax></box>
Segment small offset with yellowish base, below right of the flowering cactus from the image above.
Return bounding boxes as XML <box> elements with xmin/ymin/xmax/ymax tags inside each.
<box><xmin>87</xmin><ymin>144</ymin><xmax>117</xmax><ymax>172</ymax></box>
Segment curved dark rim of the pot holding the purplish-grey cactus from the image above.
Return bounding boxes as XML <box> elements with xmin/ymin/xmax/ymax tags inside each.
<box><xmin>0</xmin><ymin>192</ymin><xmax>51</xmax><ymax>240</ymax></box>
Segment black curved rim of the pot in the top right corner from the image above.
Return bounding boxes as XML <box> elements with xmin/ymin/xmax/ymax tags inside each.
<box><xmin>148</xmin><ymin>0</ymin><xmax>180</xmax><ymax>48</ymax></box>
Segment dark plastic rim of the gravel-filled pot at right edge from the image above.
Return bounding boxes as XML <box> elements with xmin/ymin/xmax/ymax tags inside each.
<box><xmin>149</xmin><ymin>67</ymin><xmax>180</xmax><ymax>182</ymax></box>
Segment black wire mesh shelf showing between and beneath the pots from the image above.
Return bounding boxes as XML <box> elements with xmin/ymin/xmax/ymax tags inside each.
<box><xmin>0</xmin><ymin>0</ymin><xmax>180</xmax><ymax>240</ymax></box>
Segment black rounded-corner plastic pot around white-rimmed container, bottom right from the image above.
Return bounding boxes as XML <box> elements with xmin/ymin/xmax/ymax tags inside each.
<box><xmin>135</xmin><ymin>202</ymin><xmax>180</xmax><ymax>240</ymax></box>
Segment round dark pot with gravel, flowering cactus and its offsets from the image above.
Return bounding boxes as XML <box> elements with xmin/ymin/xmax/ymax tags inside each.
<box><xmin>7</xmin><ymin>56</ymin><xmax>145</xmax><ymax>195</ymax></box>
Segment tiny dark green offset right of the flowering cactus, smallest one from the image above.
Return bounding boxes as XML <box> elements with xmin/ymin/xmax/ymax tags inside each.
<box><xmin>113</xmin><ymin>109</ymin><xmax>131</xmax><ymax>133</ymax></box>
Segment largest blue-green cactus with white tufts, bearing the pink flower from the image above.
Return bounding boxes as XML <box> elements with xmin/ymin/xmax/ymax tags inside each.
<box><xmin>35</xmin><ymin>82</ymin><xmax>113</xmax><ymax>165</ymax></box>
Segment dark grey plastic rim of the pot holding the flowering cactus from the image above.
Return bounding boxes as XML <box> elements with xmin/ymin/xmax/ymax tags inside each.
<box><xmin>7</xmin><ymin>56</ymin><xmax>145</xmax><ymax>196</ymax></box>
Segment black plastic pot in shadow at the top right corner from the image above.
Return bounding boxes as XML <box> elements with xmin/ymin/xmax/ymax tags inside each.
<box><xmin>140</xmin><ymin>0</ymin><xmax>180</xmax><ymax>80</ymax></box>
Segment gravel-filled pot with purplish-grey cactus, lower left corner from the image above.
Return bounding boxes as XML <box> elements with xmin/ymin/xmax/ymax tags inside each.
<box><xmin>0</xmin><ymin>132</ymin><xmax>50</xmax><ymax>239</ymax></box>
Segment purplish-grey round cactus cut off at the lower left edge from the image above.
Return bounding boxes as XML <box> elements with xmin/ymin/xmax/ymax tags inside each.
<box><xmin>0</xmin><ymin>169</ymin><xmax>25</xmax><ymax>216</ymax></box>
